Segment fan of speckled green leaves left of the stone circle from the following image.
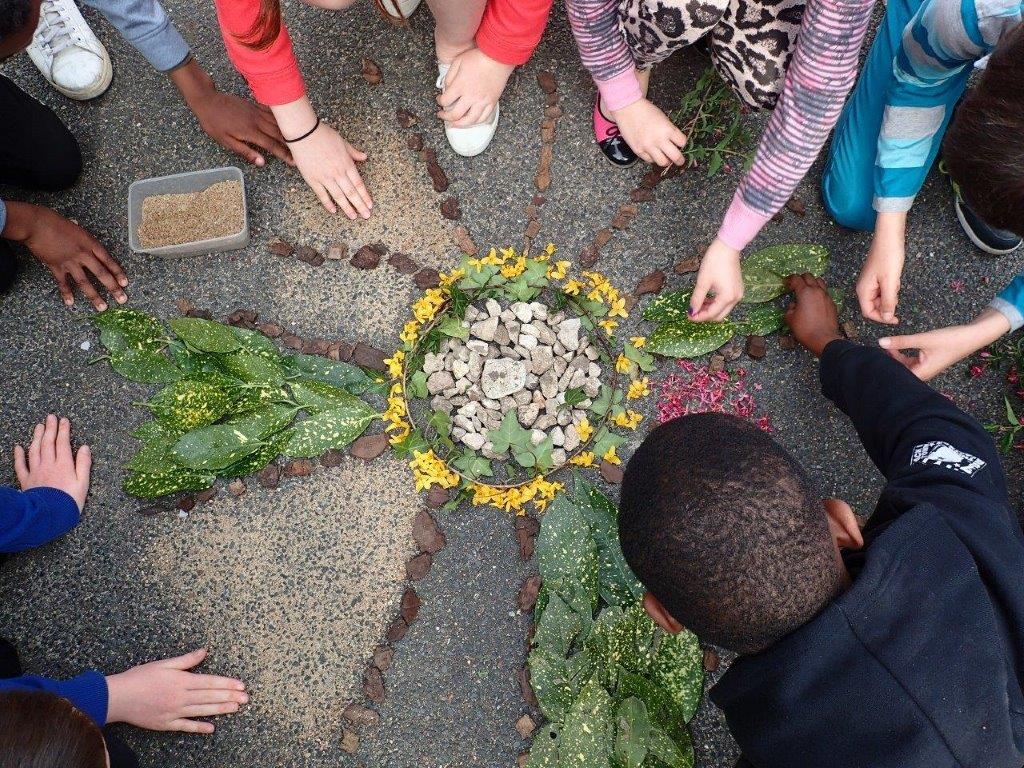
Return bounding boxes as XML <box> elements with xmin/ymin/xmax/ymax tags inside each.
<box><xmin>93</xmin><ymin>308</ymin><xmax>380</xmax><ymax>499</ymax></box>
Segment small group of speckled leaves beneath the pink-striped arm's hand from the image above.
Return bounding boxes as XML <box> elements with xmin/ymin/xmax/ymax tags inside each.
<box><xmin>643</xmin><ymin>244</ymin><xmax>828</xmax><ymax>357</ymax></box>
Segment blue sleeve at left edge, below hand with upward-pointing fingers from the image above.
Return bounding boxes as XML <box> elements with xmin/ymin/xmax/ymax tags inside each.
<box><xmin>0</xmin><ymin>486</ymin><xmax>80</xmax><ymax>552</ymax></box>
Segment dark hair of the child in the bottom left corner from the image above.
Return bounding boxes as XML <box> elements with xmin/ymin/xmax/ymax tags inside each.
<box><xmin>0</xmin><ymin>690</ymin><xmax>106</xmax><ymax>768</ymax></box>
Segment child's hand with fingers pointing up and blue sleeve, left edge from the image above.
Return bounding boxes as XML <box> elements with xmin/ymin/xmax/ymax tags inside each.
<box><xmin>0</xmin><ymin>414</ymin><xmax>92</xmax><ymax>552</ymax></box>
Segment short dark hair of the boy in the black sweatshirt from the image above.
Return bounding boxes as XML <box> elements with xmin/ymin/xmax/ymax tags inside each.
<box><xmin>618</xmin><ymin>414</ymin><xmax>842</xmax><ymax>653</ymax></box>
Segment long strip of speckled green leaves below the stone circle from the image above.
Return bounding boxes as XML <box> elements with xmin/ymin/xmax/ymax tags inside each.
<box><xmin>527</xmin><ymin>478</ymin><xmax>703</xmax><ymax>768</ymax></box>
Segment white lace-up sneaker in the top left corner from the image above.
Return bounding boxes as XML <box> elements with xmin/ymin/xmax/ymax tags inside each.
<box><xmin>28</xmin><ymin>0</ymin><xmax>114</xmax><ymax>101</ymax></box>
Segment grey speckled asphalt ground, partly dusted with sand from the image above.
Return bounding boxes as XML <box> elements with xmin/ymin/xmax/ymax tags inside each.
<box><xmin>0</xmin><ymin>0</ymin><xmax>1021</xmax><ymax>768</ymax></box>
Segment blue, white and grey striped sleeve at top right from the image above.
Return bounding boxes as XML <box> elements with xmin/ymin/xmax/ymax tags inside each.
<box><xmin>873</xmin><ymin>0</ymin><xmax>978</xmax><ymax>212</ymax></box>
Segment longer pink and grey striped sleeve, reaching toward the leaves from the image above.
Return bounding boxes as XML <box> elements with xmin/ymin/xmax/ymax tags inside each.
<box><xmin>718</xmin><ymin>0</ymin><xmax>874</xmax><ymax>251</ymax></box>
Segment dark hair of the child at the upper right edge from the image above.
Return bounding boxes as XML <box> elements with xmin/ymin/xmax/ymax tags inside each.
<box><xmin>942</xmin><ymin>25</ymin><xmax>1024</xmax><ymax>237</ymax></box>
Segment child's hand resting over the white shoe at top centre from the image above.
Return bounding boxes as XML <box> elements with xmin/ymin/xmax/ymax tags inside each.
<box><xmin>437</xmin><ymin>48</ymin><xmax>515</xmax><ymax>128</ymax></box>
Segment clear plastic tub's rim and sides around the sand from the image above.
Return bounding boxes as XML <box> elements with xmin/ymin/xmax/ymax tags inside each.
<box><xmin>128</xmin><ymin>165</ymin><xmax>249</xmax><ymax>256</ymax></box>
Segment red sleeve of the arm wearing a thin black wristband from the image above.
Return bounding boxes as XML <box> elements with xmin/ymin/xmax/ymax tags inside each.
<box><xmin>214</xmin><ymin>0</ymin><xmax>306</xmax><ymax>106</ymax></box>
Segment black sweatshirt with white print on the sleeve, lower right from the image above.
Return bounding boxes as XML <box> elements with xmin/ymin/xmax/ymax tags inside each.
<box><xmin>711</xmin><ymin>341</ymin><xmax>1024</xmax><ymax>768</ymax></box>
